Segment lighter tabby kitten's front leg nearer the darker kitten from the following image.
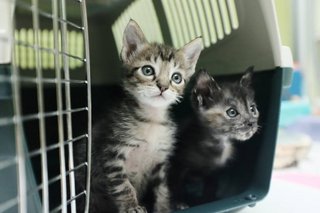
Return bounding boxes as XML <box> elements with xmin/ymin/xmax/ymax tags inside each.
<box><xmin>154</xmin><ymin>165</ymin><xmax>171</xmax><ymax>213</ymax></box>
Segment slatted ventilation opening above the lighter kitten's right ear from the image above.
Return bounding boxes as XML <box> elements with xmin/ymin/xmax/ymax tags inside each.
<box><xmin>162</xmin><ymin>0</ymin><xmax>239</xmax><ymax>47</ymax></box>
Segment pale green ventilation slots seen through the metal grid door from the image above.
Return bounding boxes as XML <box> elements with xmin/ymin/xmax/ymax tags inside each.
<box><xmin>15</xmin><ymin>28</ymin><xmax>84</xmax><ymax>70</ymax></box>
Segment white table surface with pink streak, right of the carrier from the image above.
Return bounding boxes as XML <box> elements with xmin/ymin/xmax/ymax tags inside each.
<box><xmin>241</xmin><ymin>142</ymin><xmax>320</xmax><ymax>213</ymax></box>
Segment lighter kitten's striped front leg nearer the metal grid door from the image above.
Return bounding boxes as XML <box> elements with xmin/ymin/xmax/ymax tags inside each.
<box><xmin>105</xmin><ymin>160</ymin><xmax>146</xmax><ymax>213</ymax></box>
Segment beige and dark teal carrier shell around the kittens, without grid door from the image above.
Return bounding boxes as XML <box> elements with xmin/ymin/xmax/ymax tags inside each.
<box><xmin>85</xmin><ymin>0</ymin><xmax>292</xmax><ymax>212</ymax></box>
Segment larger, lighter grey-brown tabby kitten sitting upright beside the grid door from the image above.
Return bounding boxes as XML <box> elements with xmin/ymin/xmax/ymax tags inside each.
<box><xmin>75</xmin><ymin>20</ymin><xmax>202</xmax><ymax>213</ymax></box>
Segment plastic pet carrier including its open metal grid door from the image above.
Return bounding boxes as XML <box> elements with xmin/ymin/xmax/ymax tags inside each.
<box><xmin>0</xmin><ymin>0</ymin><xmax>292</xmax><ymax>213</ymax></box>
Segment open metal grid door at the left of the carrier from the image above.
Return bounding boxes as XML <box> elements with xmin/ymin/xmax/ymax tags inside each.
<box><xmin>0</xmin><ymin>0</ymin><xmax>91</xmax><ymax>213</ymax></box>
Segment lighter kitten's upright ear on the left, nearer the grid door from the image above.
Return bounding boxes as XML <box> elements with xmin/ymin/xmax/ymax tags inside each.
<box><xmin>121</xmin><ymin>19</ymin><xmax>147</xmax><ymax>62</ymax></box>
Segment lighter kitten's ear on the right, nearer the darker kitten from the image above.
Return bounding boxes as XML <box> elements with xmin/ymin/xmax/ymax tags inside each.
<box><xmin>179</xmin><ymin>37</ymin><xmax>202</xmax><ymax>76</ymax></box>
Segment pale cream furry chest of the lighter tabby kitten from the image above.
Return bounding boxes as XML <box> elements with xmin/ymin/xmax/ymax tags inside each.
<box><xmin>125</xmin><ymin>123</ymin><xmax>174</xmax><ymax>175</ymax></box>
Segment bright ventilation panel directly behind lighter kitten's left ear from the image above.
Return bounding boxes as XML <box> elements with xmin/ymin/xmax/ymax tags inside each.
<box><xmin>112</xmin><ymin>0</ymin><xmax>163</xmax><ymax>53</ymax></box>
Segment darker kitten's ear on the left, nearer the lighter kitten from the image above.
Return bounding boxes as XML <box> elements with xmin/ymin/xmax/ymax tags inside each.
<box><xmin>192</xmin><ymin>70</ymin><xmax>221</xmax><ymax>107</ymax></box>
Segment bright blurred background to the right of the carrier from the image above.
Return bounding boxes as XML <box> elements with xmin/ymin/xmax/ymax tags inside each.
<box><xmin>244</xmin><ymin>0</ymin><xmax>320</xmax><ymax>213</ymax></box>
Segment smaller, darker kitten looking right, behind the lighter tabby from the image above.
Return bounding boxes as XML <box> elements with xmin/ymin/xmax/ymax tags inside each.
<box><xmin>169</xmin><ymin>67</ymin><xmax>259</xmax><ymax>208</ymax></box>
